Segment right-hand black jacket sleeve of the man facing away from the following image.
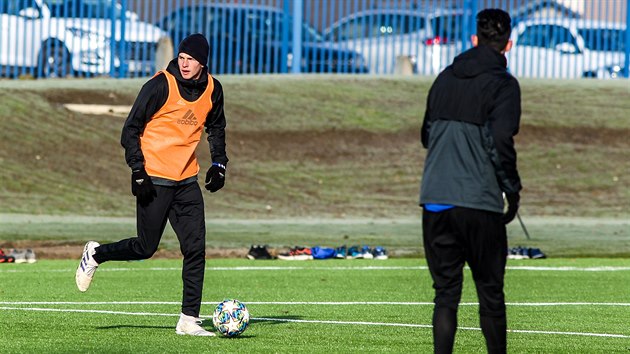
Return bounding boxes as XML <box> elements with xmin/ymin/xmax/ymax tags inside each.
<box><xmin>489</xmin><ymin>78</ymin><xmax>522</xmax><ymax>193</ymax></box>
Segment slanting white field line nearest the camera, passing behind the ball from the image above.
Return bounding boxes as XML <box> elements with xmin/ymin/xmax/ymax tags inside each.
<box><xmin>0</xmin><ymin>306</ymin><xmax>630</xmax><ymax>338</ymax></box>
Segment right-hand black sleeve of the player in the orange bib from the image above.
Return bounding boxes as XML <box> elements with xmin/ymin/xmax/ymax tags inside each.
<box><xmin>205</xmin><ymin>78</ymin><xmax>228</xmax><ymax>166</ymax></box>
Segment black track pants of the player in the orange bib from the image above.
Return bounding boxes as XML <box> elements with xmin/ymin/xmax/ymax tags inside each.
<box><xmin>94</xmin><ymin>183</ymin><xmax>206</xmax><ymax>317</ymax></box>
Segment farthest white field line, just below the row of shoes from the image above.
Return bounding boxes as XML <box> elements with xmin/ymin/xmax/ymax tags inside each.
<box><xmin>0</xmin><ymin>266</ymin><xmax>630</xmax><ymax>273</ymax></box>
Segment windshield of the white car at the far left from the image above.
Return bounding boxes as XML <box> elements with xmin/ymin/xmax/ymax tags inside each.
<box><xmin>44</xmin><ymin>0</ymin><xmax>122</xmax><ymax>19</ymax></box>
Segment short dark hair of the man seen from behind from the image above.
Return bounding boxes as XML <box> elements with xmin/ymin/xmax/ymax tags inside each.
<box><xmin>477</xmin><ymin>9</ymin><xmax>512</xmax><ymax>52</ymax></box>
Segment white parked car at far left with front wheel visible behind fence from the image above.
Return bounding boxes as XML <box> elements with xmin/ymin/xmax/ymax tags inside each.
<box><xmin>0</xmin><ymin>0</ymin><xmax>165</xmax><ymax>77</ymax></box>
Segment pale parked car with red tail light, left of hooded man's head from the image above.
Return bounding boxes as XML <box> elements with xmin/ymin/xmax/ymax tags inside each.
<box><xmin>324</xmin><ymin>9</ymin><xmax>464</xmax><ymax>75</ymax></box>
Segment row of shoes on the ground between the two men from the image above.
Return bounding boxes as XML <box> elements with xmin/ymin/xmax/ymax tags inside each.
<box><xmin>247</xmin><ymin>245</ymin><xmax>388</xmax><ymax>261</ymax></box>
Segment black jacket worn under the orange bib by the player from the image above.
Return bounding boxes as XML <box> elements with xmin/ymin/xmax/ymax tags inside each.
<box><xmin>120</xmin><ymin>59</ymin><xmax>228</xmax><ymax>174</ymax></box>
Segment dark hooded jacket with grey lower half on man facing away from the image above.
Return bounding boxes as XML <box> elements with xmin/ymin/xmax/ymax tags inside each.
<box><xmin>420</xmin><ymin>45</ymin><xmax>522</xmax><ymax>213</ymax></box>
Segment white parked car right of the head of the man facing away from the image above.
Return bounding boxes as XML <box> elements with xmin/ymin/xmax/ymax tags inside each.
<box><xmin>507</xmin><ymin>18</ymin><xmax>627</xmax><ymax>78</ymax></box>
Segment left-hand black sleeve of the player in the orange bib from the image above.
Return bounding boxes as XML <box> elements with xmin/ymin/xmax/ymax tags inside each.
<box><xmin>120</xmin><ymin>74</ymin><xmax>168</xmax><ymax>171</ymax></box>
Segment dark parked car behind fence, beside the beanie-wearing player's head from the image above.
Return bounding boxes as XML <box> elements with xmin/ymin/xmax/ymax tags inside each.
<box><xmin>156</xmin><ymin>4</ymin><xmax>367</xmax><ymax>74</ymax></box>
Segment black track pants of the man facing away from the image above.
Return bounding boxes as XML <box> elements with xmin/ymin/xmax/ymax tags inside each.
<box><xmin>422</xmin><ymin>207</ymin><xmax>507</xmax><ymax>353</ymax></box>
